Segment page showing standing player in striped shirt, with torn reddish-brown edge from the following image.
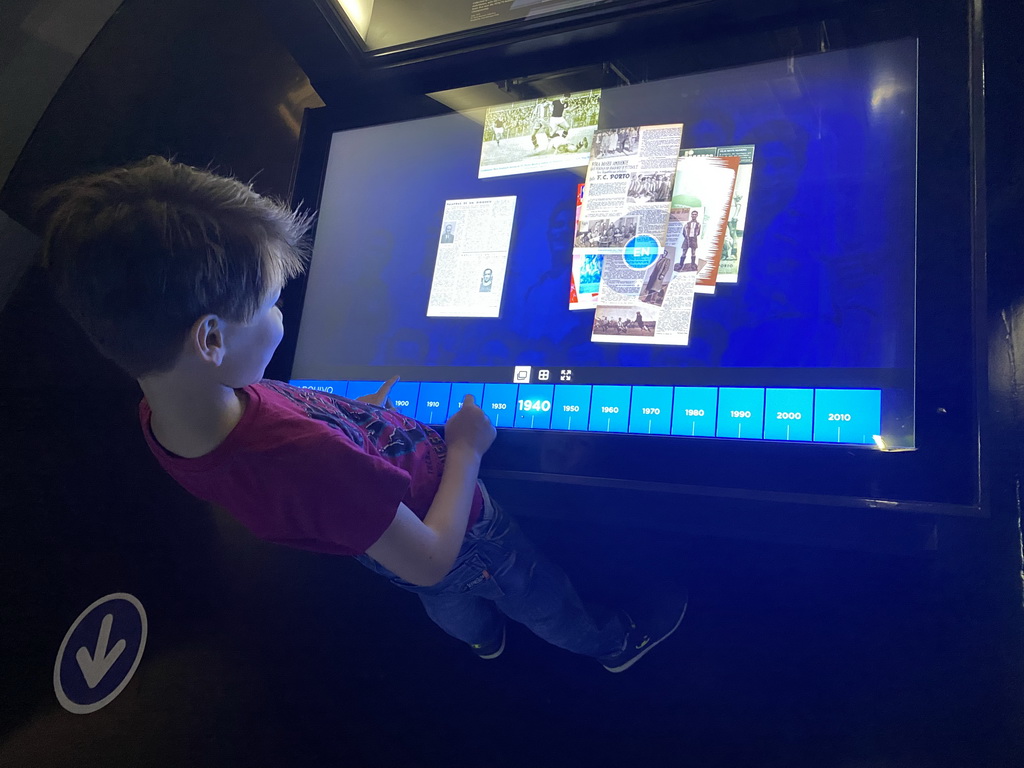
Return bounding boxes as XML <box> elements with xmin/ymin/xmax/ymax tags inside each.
<box><xmin>668</xmin><ymin>148</ymin><xmax>739</xmax><ymax>293</ymax></box>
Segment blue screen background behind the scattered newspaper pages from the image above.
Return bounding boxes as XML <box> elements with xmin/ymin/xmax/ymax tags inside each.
<box><xmin>293</xmin><ymin>40</ymin><xmax>916</xmax><ymax>379</ymax></box>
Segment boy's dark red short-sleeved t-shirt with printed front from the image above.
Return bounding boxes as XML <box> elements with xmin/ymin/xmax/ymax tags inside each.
<box><xmin>139</xmin><ymin>381</ymin><xmax>483</xmax><ymax>555</ymax></box>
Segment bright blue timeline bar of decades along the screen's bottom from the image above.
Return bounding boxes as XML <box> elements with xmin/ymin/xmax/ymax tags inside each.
<box><xmin>291</xmin><ymin>379</ymin><xmax>882</xmax><ymax>444</ymax></box>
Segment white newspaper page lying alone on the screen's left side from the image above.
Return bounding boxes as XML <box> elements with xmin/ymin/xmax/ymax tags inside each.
<box><xmin>427</xmin><ymin>197</ymin><xmax>516</xmax><ymax>317</ymax></box>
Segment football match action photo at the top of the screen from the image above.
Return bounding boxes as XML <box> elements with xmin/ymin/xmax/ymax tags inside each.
<box><xmin>477</xmin><ymin>88</ymin><xmax>601</xmax><ymax>178</ymax></box>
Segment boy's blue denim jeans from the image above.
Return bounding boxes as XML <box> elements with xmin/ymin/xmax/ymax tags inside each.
<box><xmin>356</xmin><ymin>483</ymin><xmax>627</xmax><ymax>658</ymax></box>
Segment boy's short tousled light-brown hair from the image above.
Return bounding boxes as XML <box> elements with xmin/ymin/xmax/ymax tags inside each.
<box><xmin>41</xmin><ymin>157</ymin><xmax>310</xmax><ymax>378</ymax></box>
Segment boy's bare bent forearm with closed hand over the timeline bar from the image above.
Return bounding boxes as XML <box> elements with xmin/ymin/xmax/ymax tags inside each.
<box><xmin>367</xmin><ymin>394</ymin><xmax>495</xmax><ymax>587</ymax></box>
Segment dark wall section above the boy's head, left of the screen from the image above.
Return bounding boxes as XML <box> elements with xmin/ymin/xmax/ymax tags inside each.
<box><xmin>0</xmin><ymin>0</ymin><xmax>319</xmax><ymax>223</ymax></box>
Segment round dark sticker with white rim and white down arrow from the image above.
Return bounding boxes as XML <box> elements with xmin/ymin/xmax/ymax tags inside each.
<box><xmin>53</xmin><ymin>592</ymin><xmax>146</xmax><ymax>715</ymax></box>
